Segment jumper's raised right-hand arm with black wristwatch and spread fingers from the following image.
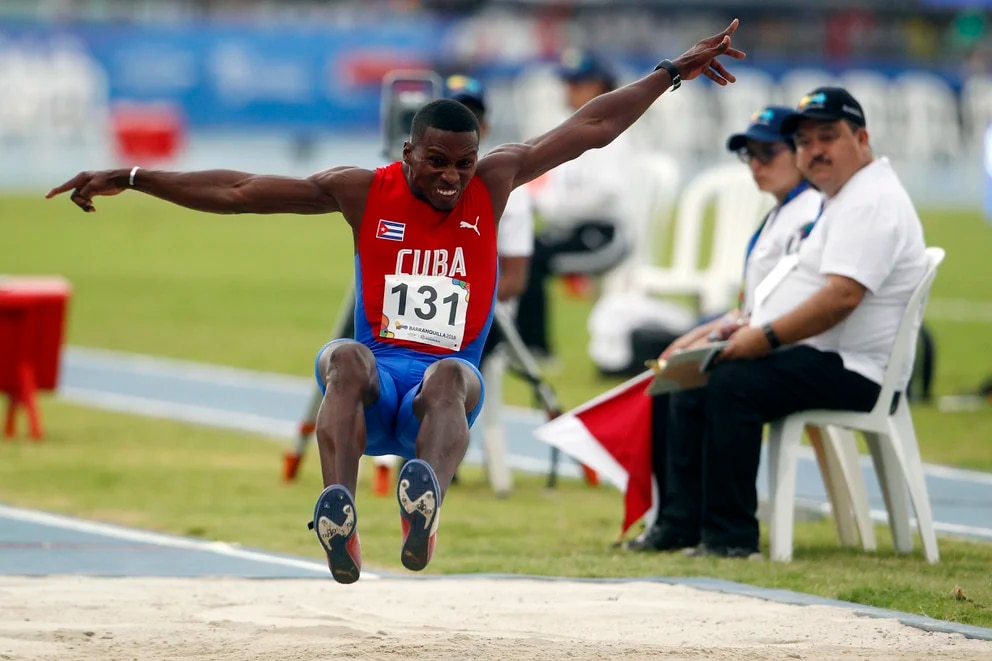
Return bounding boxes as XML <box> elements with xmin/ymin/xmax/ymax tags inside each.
<box><xmin>487</xmin><ymin>19</ymin><xmax>744</xmax><ymax>187</ymax></box>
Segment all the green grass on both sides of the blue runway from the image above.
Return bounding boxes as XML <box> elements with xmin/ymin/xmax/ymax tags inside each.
<box><xmin>0</xmin><ymin>194</ymin><xmax>992</xmax><ymax>626</ymax></box>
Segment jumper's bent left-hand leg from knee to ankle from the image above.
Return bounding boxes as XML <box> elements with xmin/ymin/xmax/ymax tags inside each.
<box><xmin>316</xmin><ymin>340</ymin><xmax>379</xmax><ymax>493</ymax></box>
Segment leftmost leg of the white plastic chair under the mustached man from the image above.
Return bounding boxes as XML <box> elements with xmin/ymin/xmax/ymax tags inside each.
<box><xmin>768</xmin><ymin>416</ymin><xmax>803</xmax><ymax>562</ymax></box>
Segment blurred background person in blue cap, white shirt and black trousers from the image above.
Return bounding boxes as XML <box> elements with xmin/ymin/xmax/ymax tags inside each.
<box><xmin>517</xmin><ymin>50</ymin><xmax>634</xmax><ymax>357</ymax></box>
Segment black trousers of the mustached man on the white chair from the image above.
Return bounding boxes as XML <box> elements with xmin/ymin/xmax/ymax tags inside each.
<box><xmin>655</xmin><ymin>345</ymin><xmax>881</xmax><ymax>550</ymax></box>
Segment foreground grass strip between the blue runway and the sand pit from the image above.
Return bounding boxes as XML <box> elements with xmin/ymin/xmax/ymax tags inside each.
<box><xmin>0</xmin><ymin>399</ymin><xmax>992</xmax><ymax>626</ymax></box>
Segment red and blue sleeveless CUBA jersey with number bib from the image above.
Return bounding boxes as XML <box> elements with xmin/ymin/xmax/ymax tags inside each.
<box><xmin>355</xmin><ymin>162</ymin><xmax>497</xmax><ymax>366</ymax></box>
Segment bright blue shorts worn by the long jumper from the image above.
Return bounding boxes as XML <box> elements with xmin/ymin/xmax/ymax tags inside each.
<box><xmin>314</xmin><ymin>339</ymin><xmax>486</xmax><ymax>459</ymax></box>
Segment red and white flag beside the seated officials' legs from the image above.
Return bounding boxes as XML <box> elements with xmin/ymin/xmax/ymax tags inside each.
<box><xmin>534</xmin><ymin>371</ymin><xmax>653</xmax><ymax>535</ymax></box>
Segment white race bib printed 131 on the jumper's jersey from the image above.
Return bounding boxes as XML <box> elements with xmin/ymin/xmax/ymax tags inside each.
<box><xmin>379</xmin><ymin>274</ymin><xmax>468</xmax><ymax>351</ymax></box>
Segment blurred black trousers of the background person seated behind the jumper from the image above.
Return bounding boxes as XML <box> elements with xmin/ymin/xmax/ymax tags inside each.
<box><xmin>517</xmin><ymin>221</ymin><xmax>628</xmax><ymax>354</ymax></box>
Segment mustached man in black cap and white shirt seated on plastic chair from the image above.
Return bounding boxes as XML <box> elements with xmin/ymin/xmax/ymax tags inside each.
<box><xmin>662</xmin><ymin>87</ymin><xmax>926</xmax><ymax>557</ymax></box>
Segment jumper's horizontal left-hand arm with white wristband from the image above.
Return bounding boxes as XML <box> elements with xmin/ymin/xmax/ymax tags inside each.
<box><xmin>45</xmin><ymin>168</ymin><xmax>350</xmax><ymax>214</ymax></box>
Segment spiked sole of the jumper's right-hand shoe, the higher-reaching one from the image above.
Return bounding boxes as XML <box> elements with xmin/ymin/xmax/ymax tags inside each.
<box><xmin>396</xmin><ymin>459</ymin><xmax>441</xmax><ymax>571</ymax></box>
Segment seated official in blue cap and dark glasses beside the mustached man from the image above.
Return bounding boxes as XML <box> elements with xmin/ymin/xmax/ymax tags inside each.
<box><xmin>626</xmin><ymin>106</ymin><xmax>823</xmax><ymax>551</ymax></box>
